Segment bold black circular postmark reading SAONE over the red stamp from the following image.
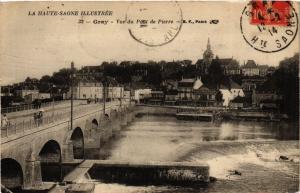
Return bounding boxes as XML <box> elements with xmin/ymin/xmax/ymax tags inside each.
<box><xmin>240</xmin><ymin>1</ymin><xmax>298</xmax><ymax>53</ymax></box>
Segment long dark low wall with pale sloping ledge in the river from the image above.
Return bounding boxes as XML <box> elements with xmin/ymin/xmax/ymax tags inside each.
<box><xmin>64</xmin><ymin>160</ymin><xmax>209</xmax><ymax>186</ymax></box>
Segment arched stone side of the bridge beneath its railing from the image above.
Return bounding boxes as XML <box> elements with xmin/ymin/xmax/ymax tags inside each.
<box><xmin>1</xmin><ymin>102</ymin><xmax>134</xmax><ymax>189</ymax></box>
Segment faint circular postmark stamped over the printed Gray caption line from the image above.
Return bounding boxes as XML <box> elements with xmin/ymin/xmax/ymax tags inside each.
<box><xmin>126</xmin><ymin>2</ymin><xmax>183</xmax><ymax>47</ymax></box>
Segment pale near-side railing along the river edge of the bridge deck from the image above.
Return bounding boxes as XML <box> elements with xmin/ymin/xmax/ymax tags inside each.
<box><xmin>1</xmin><ymin>99</ymin><xmax>130</xmax><ymax>138</ymax></box>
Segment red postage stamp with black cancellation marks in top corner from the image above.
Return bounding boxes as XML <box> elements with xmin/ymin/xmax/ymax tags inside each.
<box><xmin>250</xmin><ymin>0</ymin><xmax>291</xmax><ymax>26</ymax></box>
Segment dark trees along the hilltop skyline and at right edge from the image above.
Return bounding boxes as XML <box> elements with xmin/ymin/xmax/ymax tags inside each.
<box><xmin>1</xmin><ymin>53</ymin><xmax>299</xmax><ymax>118</ymax></box>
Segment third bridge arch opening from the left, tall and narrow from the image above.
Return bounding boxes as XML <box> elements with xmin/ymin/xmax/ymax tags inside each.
<box><xmin>71</xmin><ymin>127</ymin><xmax>84</xmax><ymax>159</ymax></box>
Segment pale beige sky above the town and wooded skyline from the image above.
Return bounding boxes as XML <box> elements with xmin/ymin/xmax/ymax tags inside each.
<box><xmin>0</xmin><ymin>2</ymin><xmax>299</xmax><ymax>85</ymax></box>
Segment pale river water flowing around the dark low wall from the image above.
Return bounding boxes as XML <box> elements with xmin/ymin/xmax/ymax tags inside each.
<box><xmin>85</xmin><ymin>116</ymin><xmax>300</xmax><ymax>193</ymax></box>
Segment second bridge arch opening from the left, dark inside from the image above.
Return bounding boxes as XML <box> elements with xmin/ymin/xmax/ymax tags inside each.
<box><xmin>39</xmin><ymin>140</ymin><xmax>62</xmax><ymax>181</ymax></box>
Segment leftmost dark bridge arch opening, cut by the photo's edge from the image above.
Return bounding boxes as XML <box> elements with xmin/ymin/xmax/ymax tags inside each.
<box><xmin>1</xmin><ymin>158</ymin><xmax>24</xmax><ymax>191</ymax></box>
